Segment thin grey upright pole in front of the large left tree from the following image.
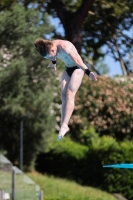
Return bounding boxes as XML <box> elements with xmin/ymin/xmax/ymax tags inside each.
<box><xmin>20</xmin><ymin>117</ymin><xmax>23</xmax><ymax>171</ymax></box>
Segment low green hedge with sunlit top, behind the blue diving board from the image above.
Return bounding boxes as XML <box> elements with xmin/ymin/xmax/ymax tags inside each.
<box><xmin>36</xmin><ymin>131</ymin><xmax>133</xmax><ymax>200</ymax></box>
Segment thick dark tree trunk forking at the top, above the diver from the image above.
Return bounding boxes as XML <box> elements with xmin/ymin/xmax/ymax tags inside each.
<box><xmin>51</xmin><ymin>0</ymin><xmax>94</xmax><ymax>53</ymax></box>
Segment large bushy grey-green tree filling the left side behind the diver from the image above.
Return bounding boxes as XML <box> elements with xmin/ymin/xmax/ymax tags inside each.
<box><xmin>0</xmin><ymin>5</ymin><xmax>56</xmax><ymax>167</ymax></box>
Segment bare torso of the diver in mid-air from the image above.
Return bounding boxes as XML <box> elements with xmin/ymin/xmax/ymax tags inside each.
<box><xmin>53</xmin><ymin>40</ymin><xmax>78</xmax><ymax>67</ymax></box>
